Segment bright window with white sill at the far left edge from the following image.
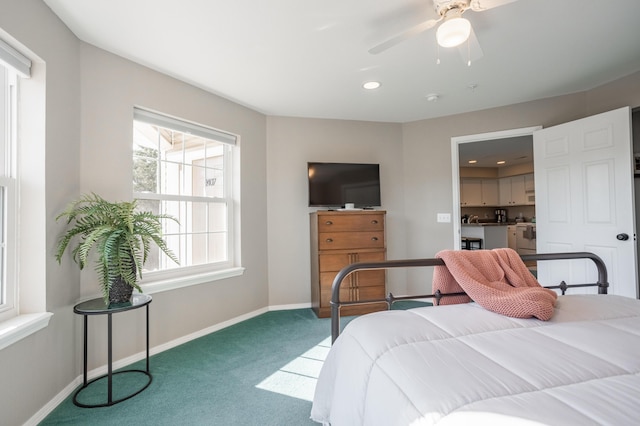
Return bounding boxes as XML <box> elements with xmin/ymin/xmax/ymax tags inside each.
<box><xmin>0</xmin><ymin>36</ymin><xmax>53</xmax><ymax>350</ymax></box>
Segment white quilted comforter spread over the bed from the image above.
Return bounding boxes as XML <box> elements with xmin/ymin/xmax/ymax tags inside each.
<box><xmin>311</xmin><ymin>295</ymin><xmax>640</xmax><ymax>426</ymax></box>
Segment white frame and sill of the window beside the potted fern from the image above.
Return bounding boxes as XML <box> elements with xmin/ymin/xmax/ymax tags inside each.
<box><xmin>133</xmin><ymin>107</ymin><xmax>244</xmax><ymax>293</ymax></box>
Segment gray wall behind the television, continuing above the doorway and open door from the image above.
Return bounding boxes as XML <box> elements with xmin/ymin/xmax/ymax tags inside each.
<box><xmin>267</xmin><ymin>73</ymin><xmax>640</xmax><ymax>305</ymax></box>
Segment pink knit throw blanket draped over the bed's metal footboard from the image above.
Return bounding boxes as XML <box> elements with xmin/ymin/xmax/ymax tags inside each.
<box><xmin>433</xmin><ymin>248</ymin><xmax>558</xmax><ymax>321</ymax></box>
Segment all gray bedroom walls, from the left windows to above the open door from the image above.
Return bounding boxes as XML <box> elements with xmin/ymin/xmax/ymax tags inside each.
<box><xmin>0</xmin><ymin>0</ymin><xmax>640</xmax><ymax>425</ymax></box>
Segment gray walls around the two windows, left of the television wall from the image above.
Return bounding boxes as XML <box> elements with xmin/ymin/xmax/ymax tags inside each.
<box><xmin>0</xmin><ymin>0</ymin><xmax>269</xmax><ymax>425</ymax></box>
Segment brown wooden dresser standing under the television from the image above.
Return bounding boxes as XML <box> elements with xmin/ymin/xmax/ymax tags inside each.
<box><xmin>310</xmin><ymin>210</ymin><xmax>387</xmax><ymax>317</ymax></box>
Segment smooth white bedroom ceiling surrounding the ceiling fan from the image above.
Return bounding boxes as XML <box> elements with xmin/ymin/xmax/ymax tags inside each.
<box><xmin>44</xmin><ymin>0</ymin><xmax>640</xmax><ymax>122</ymax></box>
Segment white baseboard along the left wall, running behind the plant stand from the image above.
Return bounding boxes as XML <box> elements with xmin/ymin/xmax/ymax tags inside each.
<box><xmin>23</xmin><ymin>303</ymin><xmax>311</xmax><ymax>426</ymax></box>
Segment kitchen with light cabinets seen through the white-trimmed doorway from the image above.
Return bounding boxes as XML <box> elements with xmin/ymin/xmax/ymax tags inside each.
<box><xmin>451</xmin><ymin>126</ymin><xmax>541</xmax><ymax>254</ymax></box>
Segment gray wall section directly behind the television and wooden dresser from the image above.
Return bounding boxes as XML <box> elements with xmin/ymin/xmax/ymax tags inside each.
<box><xmin>267</xmin><ymin>117</ymin><xmax>405</xmax><ymax>306</ymax></box>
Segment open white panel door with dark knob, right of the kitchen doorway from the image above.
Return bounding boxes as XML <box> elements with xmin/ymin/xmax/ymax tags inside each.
<box><xmin>533</xmin><ymin>108</ymin><xmax>638</xmax><ymax>298</ymax></box>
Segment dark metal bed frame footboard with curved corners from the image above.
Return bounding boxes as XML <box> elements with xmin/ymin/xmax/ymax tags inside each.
<box><xmin>330</xmin><ymin>252</ymin><xmax>609</xmax><ymax>343</ymax></box>
